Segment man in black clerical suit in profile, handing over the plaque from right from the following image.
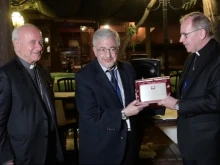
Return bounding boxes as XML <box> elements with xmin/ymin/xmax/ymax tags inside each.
<box><xmin>159</xmin><ymin>12</ymin><xmax>220</xmax><ymax>165</ymax></box>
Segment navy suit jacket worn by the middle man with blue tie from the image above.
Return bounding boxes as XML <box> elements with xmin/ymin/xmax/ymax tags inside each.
<box><xmin>75</xmin><ymin>59</ymin><xmax>137</xmax><ymax>164</ymax></box>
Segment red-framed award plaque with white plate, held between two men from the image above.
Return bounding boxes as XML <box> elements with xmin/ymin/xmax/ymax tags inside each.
<box><xmin>135</xmin><ymin>76</ymin><xmax>171</xmax><ymax>103</ymax></box>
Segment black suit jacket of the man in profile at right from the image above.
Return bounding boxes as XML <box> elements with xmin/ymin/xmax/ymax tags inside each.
<box><xmin>177</xmin><ymin>39</ymin><xmax>220</xmax><ymax>160</ymax></box>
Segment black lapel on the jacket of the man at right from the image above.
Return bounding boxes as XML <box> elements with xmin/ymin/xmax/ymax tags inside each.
<box><xmin>180</xmin><ymin>39</ymin><xmax>216</xmax><ymax>96</ymax></box>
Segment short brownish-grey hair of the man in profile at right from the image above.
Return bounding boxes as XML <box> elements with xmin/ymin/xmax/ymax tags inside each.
<box><xmin>180</xmin><ymin>12</ymin><xmax>213</xmax><ymax>37</ymax></box>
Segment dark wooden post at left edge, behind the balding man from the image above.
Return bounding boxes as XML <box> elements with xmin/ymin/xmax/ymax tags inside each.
<box><xmin>0</xmin><ymin>0</ymin><xmax>13</xmax><ymax>66</ymax></box>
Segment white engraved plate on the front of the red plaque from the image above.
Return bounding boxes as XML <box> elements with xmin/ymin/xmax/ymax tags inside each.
<box><xmin>140</xmin><ymin>82</ymin><xmax>167</xmax><ymax>103</ymax></box>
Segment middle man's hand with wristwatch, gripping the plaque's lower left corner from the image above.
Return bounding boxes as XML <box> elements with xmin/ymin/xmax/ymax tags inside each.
<box><xmin>124</xmin><ymin>100</ymin><xmax>149</xmax><ymax>116</ymax></box>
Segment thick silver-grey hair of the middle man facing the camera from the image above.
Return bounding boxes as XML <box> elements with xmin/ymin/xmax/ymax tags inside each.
<box><xmin>93</xmin><ymin>28</ymin><xmax>120</xmax><ymax>47</ymax></box>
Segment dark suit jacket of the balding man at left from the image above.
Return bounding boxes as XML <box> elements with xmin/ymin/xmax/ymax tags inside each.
<box><xmin>0</xmin><ymin>57</ymin><xmax>63</xmax><ymax>164</ymax></box>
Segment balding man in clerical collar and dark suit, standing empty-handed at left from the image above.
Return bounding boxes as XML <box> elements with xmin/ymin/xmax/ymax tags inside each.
<box><xmin>0</xmin><ymin>24</ymin><xmax>63</xmax><ymax>165</ymax></box>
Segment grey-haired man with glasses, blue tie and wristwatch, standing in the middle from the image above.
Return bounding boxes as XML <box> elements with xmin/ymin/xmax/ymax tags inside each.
<box><xmin>75</xmin><ymin>29</ymin><xmax>148</xmax><ymax>165</ymax></box>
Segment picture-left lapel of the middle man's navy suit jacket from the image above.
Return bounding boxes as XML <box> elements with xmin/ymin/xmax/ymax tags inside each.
<box><xmin>94</xmin><ymin>59</ymin><xmax>124</xmax><ymax>107</ymax></box>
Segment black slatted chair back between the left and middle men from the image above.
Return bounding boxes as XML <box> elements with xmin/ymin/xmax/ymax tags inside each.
<box><xmin>57</xmin><ymin>77</ymin><xmax>75</xmax><ymax>92</ymax></box>
